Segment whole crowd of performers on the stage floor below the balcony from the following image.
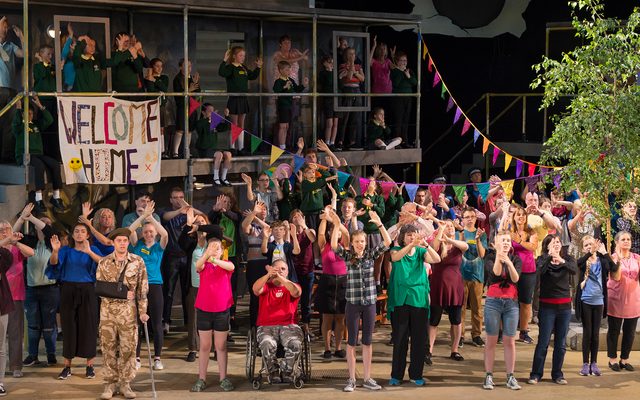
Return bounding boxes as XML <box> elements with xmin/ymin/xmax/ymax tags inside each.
<box><xmin>0</xmin><ymin>153</ymin><xmax>640</xmax><ymax>399</ymax></box>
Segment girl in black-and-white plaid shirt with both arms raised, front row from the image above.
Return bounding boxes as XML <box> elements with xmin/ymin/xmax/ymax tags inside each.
<box><xmin>328</xmin><ymin>210</ymin><xmax>391</xmax><ymax>392</ymax></box>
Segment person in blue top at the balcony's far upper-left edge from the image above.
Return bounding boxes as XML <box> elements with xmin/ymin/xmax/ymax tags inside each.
<box><xmin>0</xmin><ymin>17</ymin><xmax>24</xmax><ymax>163</ymax></box>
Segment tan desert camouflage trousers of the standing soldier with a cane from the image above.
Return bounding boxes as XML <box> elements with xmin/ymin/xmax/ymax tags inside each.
<box><xmin>100</xmin><ymin>298</ymin><xmax>138</xmax><ymax>385</ymax></box>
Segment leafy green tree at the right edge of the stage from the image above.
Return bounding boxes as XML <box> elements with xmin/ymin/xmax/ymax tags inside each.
<box><xmin>531</xmin><ymin>0</ymin><xmax>640</xmax><ymax>248</ymax></box>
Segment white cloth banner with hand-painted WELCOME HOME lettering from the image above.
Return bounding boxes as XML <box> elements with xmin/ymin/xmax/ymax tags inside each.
<box><xmin>58</xmin><ymin>97</ymin><xmax>161</xmax><ymax>185</ymax></box>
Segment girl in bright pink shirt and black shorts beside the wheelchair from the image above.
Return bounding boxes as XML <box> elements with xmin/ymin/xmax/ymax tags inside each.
<box><xmin>191</xmin><ymin>237</ymin><xmax>235</xmax><ymax>392</ymax></box>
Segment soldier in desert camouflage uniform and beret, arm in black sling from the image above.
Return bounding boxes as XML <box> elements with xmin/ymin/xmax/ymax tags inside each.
<box><xmin>96</xmin><ymin>228</ymin><xmax>149</xmax><ymax>400</ymax></box>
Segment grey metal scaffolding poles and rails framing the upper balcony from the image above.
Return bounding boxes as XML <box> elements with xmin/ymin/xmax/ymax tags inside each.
<box><xmin>0</xmin><ymin>0</ymin><xmax>422</xmax><ymax>197</ymax></box>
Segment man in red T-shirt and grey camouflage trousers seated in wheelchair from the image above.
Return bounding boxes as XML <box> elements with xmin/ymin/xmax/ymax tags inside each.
<box><xmin>253</xmin><ymin>259</ymin><xmax>304</xmax><ymax>383</ymax></box>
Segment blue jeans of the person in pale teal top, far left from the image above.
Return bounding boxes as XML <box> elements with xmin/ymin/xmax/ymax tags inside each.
<box><xmin>24</xmin><ymin>285</ymin><xmax>60</xmax><ymax>357</ymax></box>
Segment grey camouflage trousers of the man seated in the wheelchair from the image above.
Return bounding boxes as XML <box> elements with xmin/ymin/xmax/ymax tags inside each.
<box><xmin>257</xmin><ymin>324</ymin><xmax>303</xmax><ymax>376</ymax></box>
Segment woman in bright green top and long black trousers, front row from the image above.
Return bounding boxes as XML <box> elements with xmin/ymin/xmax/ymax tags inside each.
<box><xmin>387</xmin><ymin>225</ymin><xmax>440</xmax><ymax>386</ymax></box>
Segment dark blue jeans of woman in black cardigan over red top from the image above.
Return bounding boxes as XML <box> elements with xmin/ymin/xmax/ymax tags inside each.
<box><xmin>530</xmin><ymin>303</ymin><xmax>571</xmax><ymax>380</ymax></box>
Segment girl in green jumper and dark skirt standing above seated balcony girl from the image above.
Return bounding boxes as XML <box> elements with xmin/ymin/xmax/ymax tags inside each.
<box><xmin>218</xmin><ymin>46</ymin><xmax>262</xmax><ymax>151</ymax></box>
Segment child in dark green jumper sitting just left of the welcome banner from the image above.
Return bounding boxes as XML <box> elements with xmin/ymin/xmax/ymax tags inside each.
<box><xmin>12</xmin><ymin>96</ymin><xmax>64</xmax><ymax>212</ymax></box>
